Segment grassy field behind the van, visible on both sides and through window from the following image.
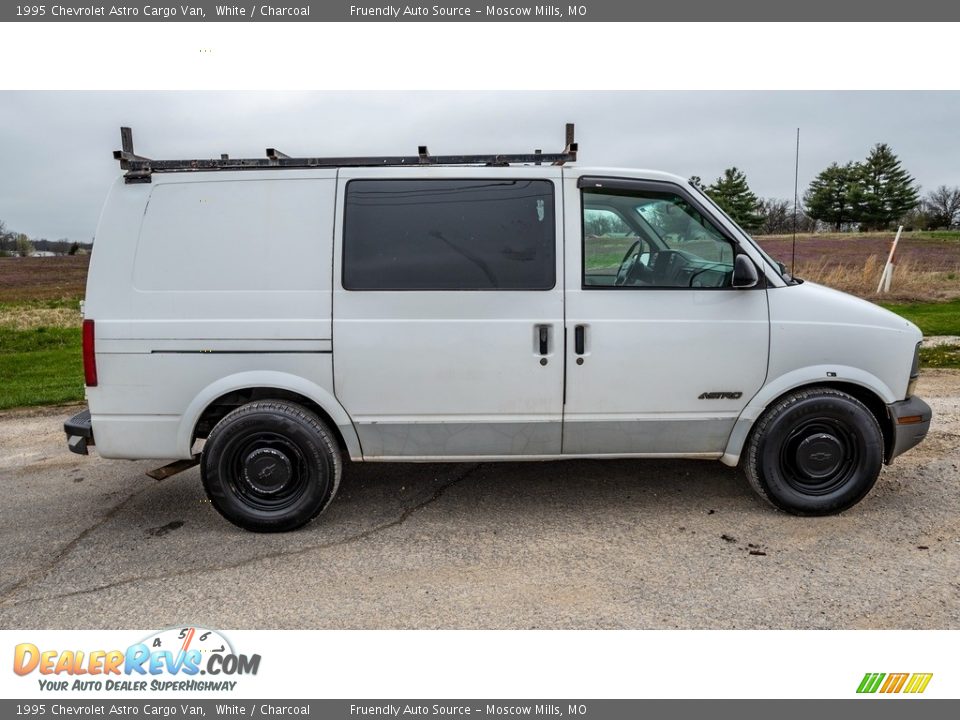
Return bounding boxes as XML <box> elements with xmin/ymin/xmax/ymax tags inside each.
<box><xmin>0</xmin><ymin>238</ymin><xmax>960</xmax><ymax>409</ymax></box>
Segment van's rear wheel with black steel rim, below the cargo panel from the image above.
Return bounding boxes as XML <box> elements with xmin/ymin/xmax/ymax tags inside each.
<box><xmin>200</xmin><ymin>400</ymin><xmax>341</xmax><ymax>532</ymax></box>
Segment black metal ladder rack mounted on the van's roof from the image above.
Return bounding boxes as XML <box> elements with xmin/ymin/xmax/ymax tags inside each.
<box><xmin>113</xmin><ymin>123</ymin><xmax>577</xmax><ymax>183</ymax></box>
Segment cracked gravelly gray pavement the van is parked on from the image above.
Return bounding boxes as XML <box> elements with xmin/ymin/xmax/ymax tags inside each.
<box><xmin>0</xmin><ymin>370</ymin><xmax>960</xmax><ymax>629</ymax></box>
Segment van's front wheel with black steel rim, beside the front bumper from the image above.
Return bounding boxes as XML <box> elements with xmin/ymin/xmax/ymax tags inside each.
<box><xmin>744</xmin><ymin>388</ymin><xmax>883</xmax><ymax>515</ymax></box>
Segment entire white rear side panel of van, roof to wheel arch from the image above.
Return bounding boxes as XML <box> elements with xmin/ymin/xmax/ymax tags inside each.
<box><xmin>85</xmin><ymin>170</ymin><xmax>342</xmax><ymax>458</ymax></box>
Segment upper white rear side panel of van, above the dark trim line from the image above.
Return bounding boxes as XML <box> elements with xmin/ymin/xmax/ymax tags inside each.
<box><xmin>97</xmin><ymin>176</ymin><xmax>335</xmax><ymax>340</ymax></box>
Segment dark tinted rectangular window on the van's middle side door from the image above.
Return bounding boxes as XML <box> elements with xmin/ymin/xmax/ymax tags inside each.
<box><xmin>343</xmin><ymin>179</ymin><xmax>556</xmax><ymax>290</ymax></box>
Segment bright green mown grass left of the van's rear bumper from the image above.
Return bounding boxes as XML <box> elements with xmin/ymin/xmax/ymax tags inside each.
<box><xmin>0</xmin><ymin>327</ymin><xmax>83</xmax><ymax>409</ymax></box>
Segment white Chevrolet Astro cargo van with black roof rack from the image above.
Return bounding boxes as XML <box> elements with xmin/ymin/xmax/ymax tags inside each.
<box><xmin>65</xmin><ymin>129</ymin><xmax>931</xmax><ymax>531</ymax></box>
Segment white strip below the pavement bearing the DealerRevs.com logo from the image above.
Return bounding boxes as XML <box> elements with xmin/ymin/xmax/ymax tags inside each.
<box><xmin>0</xmin><ymin>625</ymin><xmax>960</xmax><ymax>699</ymax></box>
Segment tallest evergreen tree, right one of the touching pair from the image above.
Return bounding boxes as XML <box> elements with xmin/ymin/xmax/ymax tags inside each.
<box><xmin>853</xmin><ymin>143</ymin><xmax>920</xmax><ymax>230</ymax></box>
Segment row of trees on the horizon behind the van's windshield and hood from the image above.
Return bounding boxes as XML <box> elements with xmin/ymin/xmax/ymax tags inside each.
<box><xmin>690</xmin><ymin>143</ymin><xmax>960</xmax><ymax>235</ymax></box>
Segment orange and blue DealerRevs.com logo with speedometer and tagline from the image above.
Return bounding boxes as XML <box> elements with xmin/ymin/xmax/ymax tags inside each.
<box><xmin>13</xmin><ymin>627</ymin><xmax>260</xmax><ymax>692</ymax></box>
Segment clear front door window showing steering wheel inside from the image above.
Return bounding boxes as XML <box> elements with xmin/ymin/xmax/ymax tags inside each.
<box><xmin>581</xmin><ymin>189</ymin><xmax>734</xmax><ymax>289</ymax></box>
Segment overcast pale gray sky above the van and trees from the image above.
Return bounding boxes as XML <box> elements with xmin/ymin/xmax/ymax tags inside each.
<box><xmin>0</xmin><ymin>91</ymin><xmax>960</xmax><ymax>241</ymax></box>
